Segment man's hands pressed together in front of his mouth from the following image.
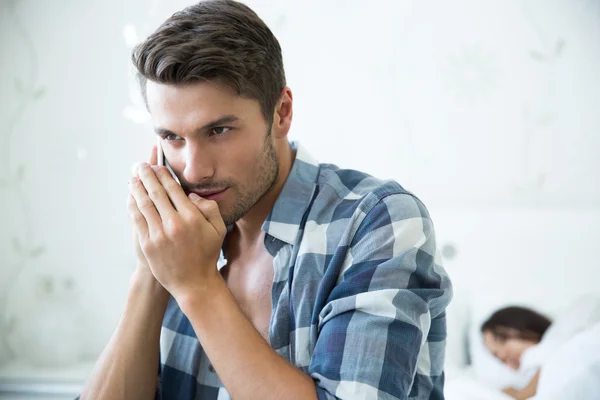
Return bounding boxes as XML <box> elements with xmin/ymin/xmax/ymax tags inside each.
<box><xmin>130</xmin><ymin>163</ymin><xmax>226</xmax><ymax>300</ymax></box>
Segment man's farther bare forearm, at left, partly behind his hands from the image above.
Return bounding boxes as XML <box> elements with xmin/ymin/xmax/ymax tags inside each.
<box><xmin>81</xmin><ymin>270</ymin><xmax>169</xmax><ymax>400</ymax></box>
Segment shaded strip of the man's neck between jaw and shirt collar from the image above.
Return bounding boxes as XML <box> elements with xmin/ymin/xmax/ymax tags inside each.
<box><xmin>235</xmin><ymin>140</ymin><xmax>296</xmax><ymax>245</ymax></box>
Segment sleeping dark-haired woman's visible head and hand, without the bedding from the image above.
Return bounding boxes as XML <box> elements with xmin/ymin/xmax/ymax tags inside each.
<box><xmin>481</xmin><ymin>307</ymin><xmax>552</xmax><ymax>399</ymax></box>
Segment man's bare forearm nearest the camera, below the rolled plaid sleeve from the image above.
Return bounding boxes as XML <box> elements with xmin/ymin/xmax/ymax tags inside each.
<box><xmin>177</xmin><ymin>279</ymin><xmax>317</xmax><ymax>400</ymax></box>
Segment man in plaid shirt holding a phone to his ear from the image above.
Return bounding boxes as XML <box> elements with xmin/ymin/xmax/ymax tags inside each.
<box><xmin>82</xmin><ymin>0</ymin><xmax>451</xmax><ymax>400</ymax></box>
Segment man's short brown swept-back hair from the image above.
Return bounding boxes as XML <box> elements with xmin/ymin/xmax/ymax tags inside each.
<box><xmin>132</xmin><ymin>0</ymin><xmax>286</xmax><ymax>124</ymax></box>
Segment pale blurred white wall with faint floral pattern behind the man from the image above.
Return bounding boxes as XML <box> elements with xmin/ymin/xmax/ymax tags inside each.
<box><xmin>0</xmin><ymin>0</ymin><xmax>600</xmax><ymax>398</ymax></box>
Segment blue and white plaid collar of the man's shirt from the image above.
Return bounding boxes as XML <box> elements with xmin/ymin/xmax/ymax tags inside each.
<box><xmin>262</xmin><ymin>142</ymin><xmax>319</xmax><ymax>244</ymax></box>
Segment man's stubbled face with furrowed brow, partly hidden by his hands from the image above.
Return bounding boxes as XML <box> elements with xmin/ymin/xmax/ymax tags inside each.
<box><xmin>146</xmin><ymin>81</ymin><xmax>278</xmax><ymax>224</ymax></box>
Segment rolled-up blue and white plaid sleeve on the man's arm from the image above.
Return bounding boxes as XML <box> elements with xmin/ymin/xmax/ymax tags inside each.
<box><xmin>308</xmin><ymin>194</ymin><xmax>452</xmax><ymax>400</ymax></box>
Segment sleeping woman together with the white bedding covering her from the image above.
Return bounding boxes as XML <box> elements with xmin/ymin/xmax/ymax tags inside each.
<box><xmin>481</xmin><ymin>304</ymin><xmax>600</xmax><ymax>400</ymax></box>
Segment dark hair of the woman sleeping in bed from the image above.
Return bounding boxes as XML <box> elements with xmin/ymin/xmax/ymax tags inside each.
<box><xmin>481</xmin><ymin>307</ymin><xmax>552</xmax><ymax>342</ymax></box>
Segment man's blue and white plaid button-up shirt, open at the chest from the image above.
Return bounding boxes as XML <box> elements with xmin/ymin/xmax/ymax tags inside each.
<box><xmin>157</xmin><ymin>143</ymin><xmax>452</xmax><ymax>400</ymax></box>
